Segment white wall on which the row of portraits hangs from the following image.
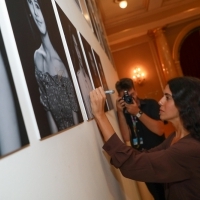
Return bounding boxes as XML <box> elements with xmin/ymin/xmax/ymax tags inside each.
<box><xmin>0</xmin><ymin>0</ymin><xmax>141</xmax><ymax>200</ymax></box>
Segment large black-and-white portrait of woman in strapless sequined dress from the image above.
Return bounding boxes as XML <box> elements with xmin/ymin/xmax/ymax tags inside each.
<box><xmin>6</xmin><ymin>0</ymin><xmax>83</xmax><ymax>138</ymax></box>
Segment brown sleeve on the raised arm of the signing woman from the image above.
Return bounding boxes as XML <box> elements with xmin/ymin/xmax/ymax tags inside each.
<box><xmin>103</xmin><ymin>134</ymin><xmax>191</xmax><ymax>183</ymax></box>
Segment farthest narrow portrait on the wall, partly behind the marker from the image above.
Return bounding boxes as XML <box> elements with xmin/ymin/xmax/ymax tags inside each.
<box><xmin>92</xmin><ymin>49</ymin><xmax>113</xmax><ymax>110</ymax></box>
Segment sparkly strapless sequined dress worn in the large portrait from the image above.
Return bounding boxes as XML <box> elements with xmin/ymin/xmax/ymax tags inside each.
<box><xmin>35</xmin><ymin>69</ymin><xmax>79</xmax><ymax>130</ymax></box>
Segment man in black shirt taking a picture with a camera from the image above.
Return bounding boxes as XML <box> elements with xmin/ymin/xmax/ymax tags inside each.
<box><xmin>115</xmin><ymin>78</ymin><xmax>165</xmax><ymax>200</ymax></box>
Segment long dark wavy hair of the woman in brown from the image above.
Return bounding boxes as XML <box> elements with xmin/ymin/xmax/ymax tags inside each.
<box><xmin>168</xmin><ymin>76</ymin><xmax>200</xmax><ymax>141</ymax></box>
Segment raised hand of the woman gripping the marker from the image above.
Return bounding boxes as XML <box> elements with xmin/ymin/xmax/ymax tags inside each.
<box><xmin>90</xmin><ymin>87</ymin><xmax>106</xmax><ymax>118</ymax></box>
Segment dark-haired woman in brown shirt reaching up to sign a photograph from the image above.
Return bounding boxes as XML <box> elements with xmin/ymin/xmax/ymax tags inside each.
<box><xmin>90</xmin><ymin>77</ymin><xmax>200</xmax><ymax>200</ymax></box>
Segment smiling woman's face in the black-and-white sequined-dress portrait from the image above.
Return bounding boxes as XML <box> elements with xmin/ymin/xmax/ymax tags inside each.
<box><xmin>27</xmin><ymin>0</ymin><xmax>46</xmax><ymax>34</ymax></box>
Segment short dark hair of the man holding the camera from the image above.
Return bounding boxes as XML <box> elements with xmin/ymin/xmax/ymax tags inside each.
<box><xmin>115</xmin><ymin>78</ymin><xmax>135</xmax><ymax>93</ymax></box>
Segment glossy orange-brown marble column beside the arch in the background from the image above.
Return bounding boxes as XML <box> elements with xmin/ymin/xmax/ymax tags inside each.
<box><xmin>149</xmin><ymin>28</ymin><xmax>179</xmax><ymax>81</ymax></box>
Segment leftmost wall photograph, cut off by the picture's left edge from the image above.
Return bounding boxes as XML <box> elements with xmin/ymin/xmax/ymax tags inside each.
<box><xmin>0</xmin><ymin>30</ymin><xmax>29</xmax><ymax>157</ymax></box>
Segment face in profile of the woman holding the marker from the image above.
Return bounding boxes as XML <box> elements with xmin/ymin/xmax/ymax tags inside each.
<box><xmin>159</xmin><ymin>85</ymin><xmax>179</xmax><ymax>122</ymax></box>
